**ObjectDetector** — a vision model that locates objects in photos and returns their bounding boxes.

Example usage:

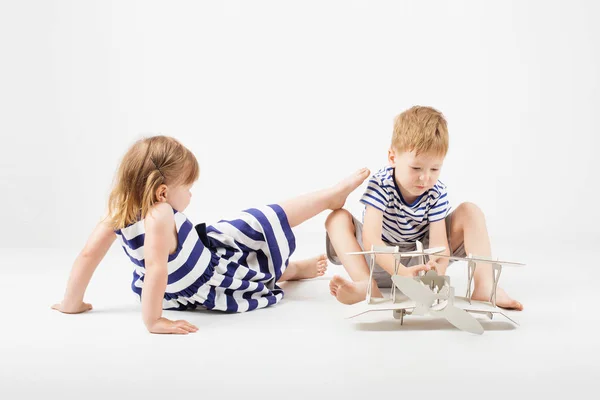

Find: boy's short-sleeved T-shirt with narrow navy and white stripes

[360,167,451,244]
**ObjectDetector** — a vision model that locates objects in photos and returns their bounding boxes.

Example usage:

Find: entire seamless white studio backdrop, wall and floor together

[0,0,600,400]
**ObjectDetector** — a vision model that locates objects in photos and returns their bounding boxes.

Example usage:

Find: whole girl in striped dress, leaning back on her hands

[52,136,369,334]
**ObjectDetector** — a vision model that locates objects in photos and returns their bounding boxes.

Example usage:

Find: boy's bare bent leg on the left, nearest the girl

[325,209,383,304]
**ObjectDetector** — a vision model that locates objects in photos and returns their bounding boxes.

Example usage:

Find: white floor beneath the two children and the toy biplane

[0,237,600,399]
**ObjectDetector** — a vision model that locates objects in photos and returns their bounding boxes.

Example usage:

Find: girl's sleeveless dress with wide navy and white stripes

[115,205,296,312]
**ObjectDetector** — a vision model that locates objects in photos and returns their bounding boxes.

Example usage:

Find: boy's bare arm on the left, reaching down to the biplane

[363,205,430,276]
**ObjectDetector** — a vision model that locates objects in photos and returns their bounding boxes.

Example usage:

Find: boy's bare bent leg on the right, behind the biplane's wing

[448,203,523,310]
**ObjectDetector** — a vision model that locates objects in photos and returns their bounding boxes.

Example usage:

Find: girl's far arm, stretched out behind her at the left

[52,217,116,314]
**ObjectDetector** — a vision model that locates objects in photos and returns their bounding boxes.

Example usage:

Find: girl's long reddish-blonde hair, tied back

[108,136,200,229]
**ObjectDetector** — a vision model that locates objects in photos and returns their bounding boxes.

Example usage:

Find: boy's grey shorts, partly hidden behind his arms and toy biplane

[325,213,467,288]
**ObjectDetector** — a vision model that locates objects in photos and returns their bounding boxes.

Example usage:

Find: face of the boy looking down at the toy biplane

[388,148,445,202]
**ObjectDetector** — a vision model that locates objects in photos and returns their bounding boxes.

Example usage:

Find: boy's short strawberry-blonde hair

[392,106,448,156]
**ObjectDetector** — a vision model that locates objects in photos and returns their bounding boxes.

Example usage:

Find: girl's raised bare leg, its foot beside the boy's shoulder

[280,168,370,228]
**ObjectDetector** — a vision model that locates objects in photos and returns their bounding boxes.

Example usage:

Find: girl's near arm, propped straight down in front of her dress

[142,203,198,334]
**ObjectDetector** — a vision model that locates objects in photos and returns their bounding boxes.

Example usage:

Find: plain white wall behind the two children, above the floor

[0,1,600,248]
